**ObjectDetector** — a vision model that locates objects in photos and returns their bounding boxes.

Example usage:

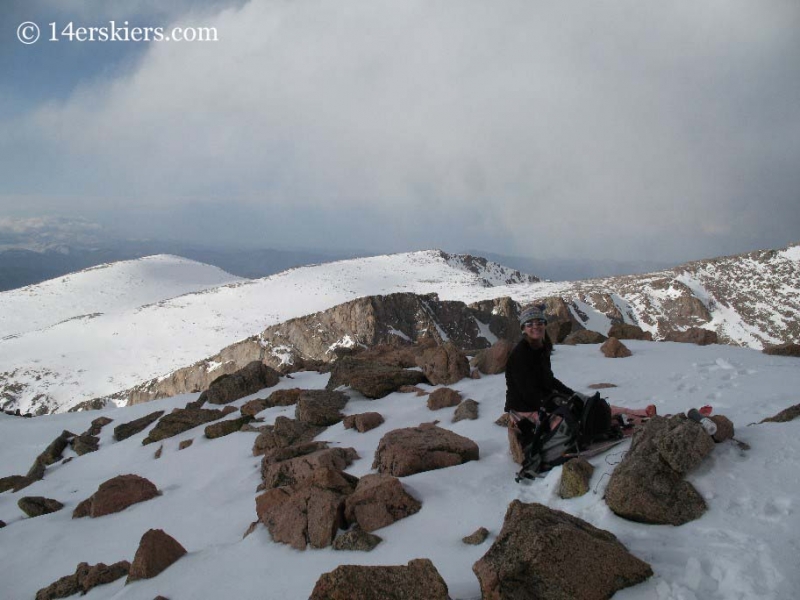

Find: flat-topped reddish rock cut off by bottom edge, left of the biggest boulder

[309,558,450,600]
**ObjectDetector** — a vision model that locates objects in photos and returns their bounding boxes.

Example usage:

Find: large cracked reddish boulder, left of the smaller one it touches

[256,467,354,550]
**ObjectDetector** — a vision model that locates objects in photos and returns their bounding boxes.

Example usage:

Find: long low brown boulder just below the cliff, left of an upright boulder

[325,356,427,399]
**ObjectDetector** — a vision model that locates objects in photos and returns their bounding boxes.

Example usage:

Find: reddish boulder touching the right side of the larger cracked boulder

[345,474,422,531]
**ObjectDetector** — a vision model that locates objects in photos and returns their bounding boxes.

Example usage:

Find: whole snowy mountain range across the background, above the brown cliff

[0,245,800,413]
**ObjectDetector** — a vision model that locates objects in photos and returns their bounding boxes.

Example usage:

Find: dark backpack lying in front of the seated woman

[517,392,622,481]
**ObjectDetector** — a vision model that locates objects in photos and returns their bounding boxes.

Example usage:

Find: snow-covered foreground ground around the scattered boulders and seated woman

[0,342,800,600]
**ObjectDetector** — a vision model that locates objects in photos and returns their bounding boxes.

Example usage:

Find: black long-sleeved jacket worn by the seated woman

[505,337,575,412]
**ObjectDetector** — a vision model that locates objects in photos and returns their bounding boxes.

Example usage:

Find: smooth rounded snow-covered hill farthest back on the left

[0,254,242,338]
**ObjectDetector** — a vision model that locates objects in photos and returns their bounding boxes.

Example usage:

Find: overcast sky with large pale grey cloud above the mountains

[0,0,800,262]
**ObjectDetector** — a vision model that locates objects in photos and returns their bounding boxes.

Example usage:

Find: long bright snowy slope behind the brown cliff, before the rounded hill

[0,250,546,412]
